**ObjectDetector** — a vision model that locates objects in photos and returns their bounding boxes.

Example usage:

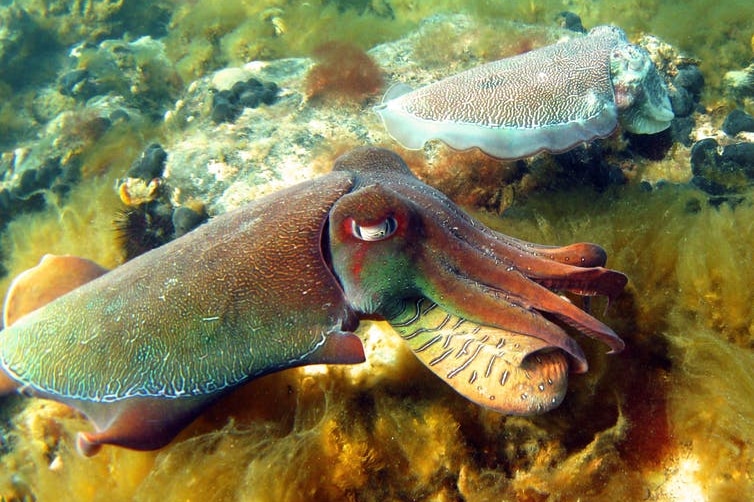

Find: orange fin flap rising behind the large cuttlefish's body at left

[3,254,108,327]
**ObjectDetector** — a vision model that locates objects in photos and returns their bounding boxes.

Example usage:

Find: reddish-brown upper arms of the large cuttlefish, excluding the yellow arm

[328,151,626,358]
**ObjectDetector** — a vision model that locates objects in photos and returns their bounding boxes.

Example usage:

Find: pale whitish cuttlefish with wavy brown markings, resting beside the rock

[375,26,673,159]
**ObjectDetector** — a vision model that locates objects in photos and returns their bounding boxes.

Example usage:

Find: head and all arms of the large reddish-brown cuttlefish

[328,148,627,414]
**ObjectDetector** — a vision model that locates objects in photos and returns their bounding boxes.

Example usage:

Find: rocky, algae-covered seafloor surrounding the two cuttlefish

[0,0,754,501]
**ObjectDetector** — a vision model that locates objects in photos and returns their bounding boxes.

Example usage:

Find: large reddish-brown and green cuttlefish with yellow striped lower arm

[0,148,627,455]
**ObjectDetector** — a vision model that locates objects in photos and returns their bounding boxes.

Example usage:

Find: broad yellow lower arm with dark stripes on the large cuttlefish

[390,298,568,415]
